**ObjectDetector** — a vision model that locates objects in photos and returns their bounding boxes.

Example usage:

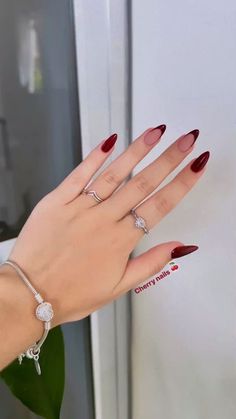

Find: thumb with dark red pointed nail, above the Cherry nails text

[117,241,198,293]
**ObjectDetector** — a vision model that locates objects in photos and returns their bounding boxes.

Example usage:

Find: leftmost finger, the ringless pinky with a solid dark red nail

[53,134,117,204]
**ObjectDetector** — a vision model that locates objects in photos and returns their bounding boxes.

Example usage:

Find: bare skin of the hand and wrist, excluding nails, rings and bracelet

[0,128,208,369]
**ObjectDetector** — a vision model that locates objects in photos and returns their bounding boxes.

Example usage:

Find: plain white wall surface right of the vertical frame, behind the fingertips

[132,0,236,419]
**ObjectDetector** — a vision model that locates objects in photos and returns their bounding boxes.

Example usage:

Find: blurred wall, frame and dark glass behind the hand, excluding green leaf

[0,0,236,419]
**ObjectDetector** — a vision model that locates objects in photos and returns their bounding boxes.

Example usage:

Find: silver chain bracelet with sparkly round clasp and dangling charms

[0,259,54,375]
